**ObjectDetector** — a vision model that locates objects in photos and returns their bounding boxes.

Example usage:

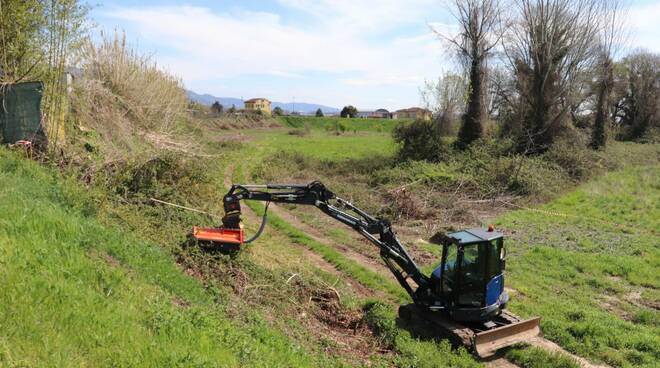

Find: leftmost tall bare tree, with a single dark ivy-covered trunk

[435,0,503,148]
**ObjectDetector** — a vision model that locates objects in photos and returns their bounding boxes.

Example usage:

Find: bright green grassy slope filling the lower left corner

[0,149,336,367]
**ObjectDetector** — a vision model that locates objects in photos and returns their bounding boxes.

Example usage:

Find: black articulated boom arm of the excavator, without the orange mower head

[222,181,431,303]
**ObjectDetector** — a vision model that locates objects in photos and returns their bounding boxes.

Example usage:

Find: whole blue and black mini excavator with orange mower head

[193,181,540,357]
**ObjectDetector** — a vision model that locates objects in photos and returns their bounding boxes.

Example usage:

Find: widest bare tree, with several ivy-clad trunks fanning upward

[505,0,601,153]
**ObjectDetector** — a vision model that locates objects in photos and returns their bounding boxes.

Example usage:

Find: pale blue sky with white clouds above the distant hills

[91,0,660,110]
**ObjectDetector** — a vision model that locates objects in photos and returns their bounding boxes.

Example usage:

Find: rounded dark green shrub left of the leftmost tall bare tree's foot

[392,120,449,162]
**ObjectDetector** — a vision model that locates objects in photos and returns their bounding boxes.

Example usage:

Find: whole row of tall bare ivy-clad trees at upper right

[418,0,660,154]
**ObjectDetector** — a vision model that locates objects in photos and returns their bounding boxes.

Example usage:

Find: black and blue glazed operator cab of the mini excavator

[431,228,509,321]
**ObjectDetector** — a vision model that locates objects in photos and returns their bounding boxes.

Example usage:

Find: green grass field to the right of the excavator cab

[498,165,660,367]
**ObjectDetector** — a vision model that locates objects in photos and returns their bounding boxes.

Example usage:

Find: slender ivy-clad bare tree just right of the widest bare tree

[590,0,625,149]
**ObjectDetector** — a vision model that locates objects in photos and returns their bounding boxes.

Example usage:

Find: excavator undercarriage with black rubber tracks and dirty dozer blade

[399,304,541,358]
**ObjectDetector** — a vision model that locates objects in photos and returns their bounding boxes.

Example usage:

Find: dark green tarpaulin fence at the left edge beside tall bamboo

[0,82,44,143]
